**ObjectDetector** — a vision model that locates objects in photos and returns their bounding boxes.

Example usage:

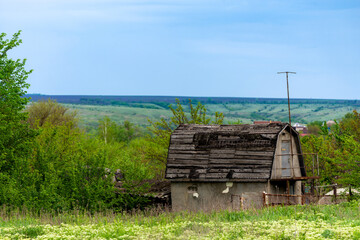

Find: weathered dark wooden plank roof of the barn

[165,123,301,182]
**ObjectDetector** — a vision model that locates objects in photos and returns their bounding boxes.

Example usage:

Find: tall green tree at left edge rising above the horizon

[0,31,36,204]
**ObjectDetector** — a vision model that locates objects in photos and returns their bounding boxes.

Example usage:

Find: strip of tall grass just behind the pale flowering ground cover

[0,201,360,227]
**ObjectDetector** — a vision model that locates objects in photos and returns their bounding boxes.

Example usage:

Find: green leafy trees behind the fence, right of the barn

[301,111,360,187]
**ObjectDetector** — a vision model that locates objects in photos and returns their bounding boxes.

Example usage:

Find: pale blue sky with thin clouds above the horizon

[0,0,360,99]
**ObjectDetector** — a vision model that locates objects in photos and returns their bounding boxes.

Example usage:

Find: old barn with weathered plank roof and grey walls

[166,123,306,211]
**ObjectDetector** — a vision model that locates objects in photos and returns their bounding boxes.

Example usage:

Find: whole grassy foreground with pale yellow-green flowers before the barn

[0,202,360,239]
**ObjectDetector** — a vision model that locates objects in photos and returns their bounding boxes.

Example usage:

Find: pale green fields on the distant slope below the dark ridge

[64,103,357,128]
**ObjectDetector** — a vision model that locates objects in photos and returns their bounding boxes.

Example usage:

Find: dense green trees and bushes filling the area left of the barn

[0,32,156,213]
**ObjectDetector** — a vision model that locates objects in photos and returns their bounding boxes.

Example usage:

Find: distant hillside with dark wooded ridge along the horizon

[27,94,360,129]
